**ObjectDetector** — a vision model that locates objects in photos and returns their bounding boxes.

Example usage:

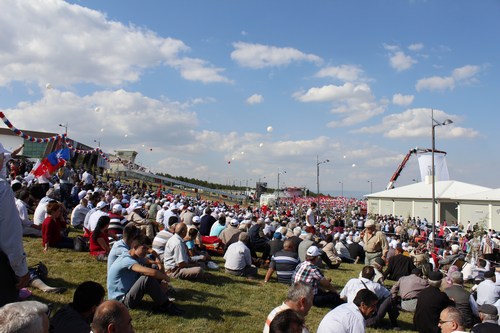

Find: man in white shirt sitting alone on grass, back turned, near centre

[224,232,257,277]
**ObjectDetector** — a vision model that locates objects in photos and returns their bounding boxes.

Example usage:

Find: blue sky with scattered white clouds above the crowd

[0,0,500,194]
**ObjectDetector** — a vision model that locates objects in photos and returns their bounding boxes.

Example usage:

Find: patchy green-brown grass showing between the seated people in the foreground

[24,233,418,333]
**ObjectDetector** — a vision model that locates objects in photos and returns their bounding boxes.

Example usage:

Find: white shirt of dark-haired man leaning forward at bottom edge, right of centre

[316,303,365,333]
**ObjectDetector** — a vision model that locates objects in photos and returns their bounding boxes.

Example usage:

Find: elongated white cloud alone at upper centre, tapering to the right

[231,42,322,68]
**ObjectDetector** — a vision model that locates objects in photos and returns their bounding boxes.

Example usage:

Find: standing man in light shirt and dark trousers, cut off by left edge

[0,146,30,307]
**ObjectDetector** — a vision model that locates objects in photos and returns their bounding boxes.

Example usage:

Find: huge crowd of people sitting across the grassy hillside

[0,146,500,333]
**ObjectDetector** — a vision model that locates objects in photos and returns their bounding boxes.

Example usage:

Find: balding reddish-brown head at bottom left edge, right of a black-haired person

[92,301,134,333]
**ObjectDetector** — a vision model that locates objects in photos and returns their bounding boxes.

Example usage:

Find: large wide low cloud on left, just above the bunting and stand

[5,89,198,149]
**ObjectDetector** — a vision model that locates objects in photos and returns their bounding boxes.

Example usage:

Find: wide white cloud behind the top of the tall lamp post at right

[354,108,479,139]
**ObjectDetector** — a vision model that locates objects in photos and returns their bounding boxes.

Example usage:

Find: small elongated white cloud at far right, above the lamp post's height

[415,65,480,91]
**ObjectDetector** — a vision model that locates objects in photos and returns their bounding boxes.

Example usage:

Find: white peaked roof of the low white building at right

[365,180,494,200]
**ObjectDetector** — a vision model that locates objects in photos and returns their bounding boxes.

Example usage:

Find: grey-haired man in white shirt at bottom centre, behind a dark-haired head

[263,280,313,333]
